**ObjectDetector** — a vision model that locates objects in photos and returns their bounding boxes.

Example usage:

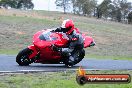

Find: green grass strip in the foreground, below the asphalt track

[0,71,132,88]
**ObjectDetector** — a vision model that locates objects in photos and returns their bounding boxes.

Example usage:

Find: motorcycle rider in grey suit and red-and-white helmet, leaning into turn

[53,19,84,65]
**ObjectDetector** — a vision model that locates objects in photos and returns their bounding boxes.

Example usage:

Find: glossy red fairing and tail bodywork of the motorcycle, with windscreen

[28,30,93,63]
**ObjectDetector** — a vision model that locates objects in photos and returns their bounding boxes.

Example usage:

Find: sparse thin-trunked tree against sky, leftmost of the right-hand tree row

[55,0,72,14]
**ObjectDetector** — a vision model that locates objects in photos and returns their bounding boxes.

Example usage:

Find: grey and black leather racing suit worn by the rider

[54,27,84,64]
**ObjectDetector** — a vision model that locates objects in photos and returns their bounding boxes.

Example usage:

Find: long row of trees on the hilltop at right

[55,0,132,24]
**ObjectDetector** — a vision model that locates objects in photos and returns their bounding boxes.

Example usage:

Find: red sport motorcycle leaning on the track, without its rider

[16,29,95,66]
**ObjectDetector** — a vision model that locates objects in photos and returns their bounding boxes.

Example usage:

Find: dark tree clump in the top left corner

[0,0,34,10]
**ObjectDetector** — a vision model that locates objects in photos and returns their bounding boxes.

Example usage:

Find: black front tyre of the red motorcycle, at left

[16,48,32,66]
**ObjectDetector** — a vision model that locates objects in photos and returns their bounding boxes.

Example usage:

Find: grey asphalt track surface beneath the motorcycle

[0,55,132,72]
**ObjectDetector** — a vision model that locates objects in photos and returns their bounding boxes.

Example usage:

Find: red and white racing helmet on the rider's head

[61,19,74,35]
